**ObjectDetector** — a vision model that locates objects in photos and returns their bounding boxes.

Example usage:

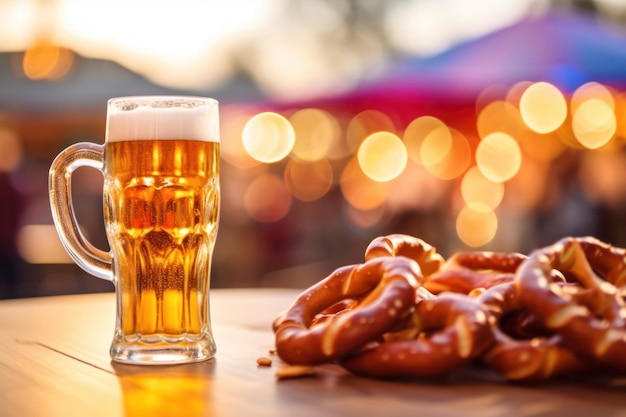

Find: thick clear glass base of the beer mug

[110,337,216,365]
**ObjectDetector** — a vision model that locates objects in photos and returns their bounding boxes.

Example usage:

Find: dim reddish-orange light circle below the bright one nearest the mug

[243,174,292,223]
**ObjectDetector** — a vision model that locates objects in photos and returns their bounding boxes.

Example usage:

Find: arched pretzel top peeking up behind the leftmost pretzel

[365,234,444,277]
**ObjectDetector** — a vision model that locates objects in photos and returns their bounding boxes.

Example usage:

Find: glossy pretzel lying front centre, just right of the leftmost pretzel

[340,293,493,378]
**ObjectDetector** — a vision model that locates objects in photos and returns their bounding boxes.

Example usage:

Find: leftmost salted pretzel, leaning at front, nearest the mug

[273,257,423,365]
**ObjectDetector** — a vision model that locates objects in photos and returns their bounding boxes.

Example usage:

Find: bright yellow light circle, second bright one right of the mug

[357,132,408,182]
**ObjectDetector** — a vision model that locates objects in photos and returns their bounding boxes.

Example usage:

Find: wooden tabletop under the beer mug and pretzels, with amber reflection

[0,289,626,417]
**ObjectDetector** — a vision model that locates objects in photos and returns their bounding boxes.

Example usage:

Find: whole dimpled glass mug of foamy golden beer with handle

[49,96,220,364]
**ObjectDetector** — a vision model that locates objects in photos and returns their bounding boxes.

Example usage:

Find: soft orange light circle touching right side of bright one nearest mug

[289,108,340,161]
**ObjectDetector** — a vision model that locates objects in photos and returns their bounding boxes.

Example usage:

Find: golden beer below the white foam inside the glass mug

[104,140,220,342]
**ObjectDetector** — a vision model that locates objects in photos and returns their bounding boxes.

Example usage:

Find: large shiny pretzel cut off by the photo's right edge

[516,237,626,370]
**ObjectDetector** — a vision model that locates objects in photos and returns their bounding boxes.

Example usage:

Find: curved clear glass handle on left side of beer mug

[48,142,113,281]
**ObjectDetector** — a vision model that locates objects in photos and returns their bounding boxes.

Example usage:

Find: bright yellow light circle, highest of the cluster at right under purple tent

[519,82,567,133]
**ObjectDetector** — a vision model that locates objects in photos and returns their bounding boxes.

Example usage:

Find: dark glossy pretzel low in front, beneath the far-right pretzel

[478,282,587,381]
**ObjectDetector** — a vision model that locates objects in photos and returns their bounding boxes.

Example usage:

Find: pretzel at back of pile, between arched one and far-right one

[424,251,564,294]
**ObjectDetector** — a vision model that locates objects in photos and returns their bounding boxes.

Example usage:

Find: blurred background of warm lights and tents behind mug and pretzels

[0,0,626,298]
